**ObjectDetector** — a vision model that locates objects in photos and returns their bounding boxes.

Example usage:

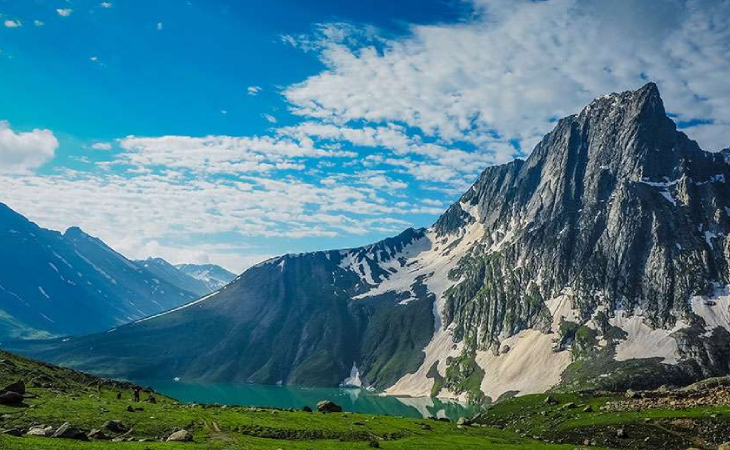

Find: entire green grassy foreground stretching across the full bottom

[0,351,730,450]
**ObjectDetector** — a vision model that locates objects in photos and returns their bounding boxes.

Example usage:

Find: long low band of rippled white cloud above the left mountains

[0,158,438,267]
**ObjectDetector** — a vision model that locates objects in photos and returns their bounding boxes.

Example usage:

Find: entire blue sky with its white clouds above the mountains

[0,0,730,271]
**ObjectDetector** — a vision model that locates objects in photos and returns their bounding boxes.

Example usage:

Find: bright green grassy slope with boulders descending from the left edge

[0,352,604,450]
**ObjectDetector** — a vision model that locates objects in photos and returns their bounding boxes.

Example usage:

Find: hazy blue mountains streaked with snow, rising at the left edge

[0,203,233,339]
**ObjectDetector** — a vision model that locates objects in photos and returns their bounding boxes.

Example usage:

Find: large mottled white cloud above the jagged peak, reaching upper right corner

[285,0,730,153]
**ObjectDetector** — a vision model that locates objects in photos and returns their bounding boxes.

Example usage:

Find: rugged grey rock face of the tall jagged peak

[438,84,730,348]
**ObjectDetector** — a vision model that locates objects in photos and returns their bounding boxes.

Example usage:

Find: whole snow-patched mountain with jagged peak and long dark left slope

[9,83,730,401]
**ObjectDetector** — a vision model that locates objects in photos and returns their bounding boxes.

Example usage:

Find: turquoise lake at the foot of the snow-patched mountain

[139,380,477,420]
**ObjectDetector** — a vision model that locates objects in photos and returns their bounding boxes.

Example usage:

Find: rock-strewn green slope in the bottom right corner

[477,384,730,450]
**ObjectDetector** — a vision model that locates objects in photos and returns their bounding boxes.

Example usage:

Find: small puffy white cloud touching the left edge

[0,121,58,172]
